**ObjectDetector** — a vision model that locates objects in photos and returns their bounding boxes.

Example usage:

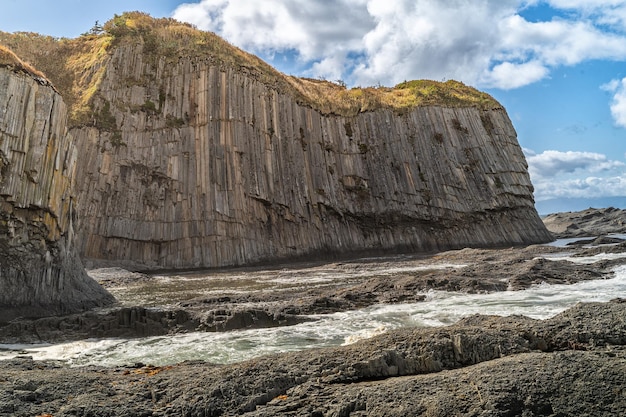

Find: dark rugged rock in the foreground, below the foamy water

[0,300,626,417]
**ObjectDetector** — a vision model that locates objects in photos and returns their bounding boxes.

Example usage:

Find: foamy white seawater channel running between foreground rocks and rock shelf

[0,254,626,366]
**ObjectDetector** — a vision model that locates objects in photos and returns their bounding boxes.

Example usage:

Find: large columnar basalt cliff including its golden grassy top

[4,13,551,268]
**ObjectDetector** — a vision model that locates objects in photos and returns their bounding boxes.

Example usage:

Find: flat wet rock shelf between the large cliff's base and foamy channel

[0,244,626,343]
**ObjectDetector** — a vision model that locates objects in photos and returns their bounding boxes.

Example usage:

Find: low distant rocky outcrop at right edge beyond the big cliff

[543,207,626,239]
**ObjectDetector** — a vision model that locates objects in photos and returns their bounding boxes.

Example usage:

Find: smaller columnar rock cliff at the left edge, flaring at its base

[0,67,113,321]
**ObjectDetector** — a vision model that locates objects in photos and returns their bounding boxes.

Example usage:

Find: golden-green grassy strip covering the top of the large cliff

[0,12,502,124]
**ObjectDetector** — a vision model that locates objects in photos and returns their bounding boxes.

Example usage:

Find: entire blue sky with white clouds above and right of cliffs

[0,0,626,214]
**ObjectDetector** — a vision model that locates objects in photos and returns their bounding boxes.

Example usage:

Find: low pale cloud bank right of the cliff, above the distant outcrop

[524,149,626,201]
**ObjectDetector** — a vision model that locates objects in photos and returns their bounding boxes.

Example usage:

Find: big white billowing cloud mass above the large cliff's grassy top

[173,0,626,89]
